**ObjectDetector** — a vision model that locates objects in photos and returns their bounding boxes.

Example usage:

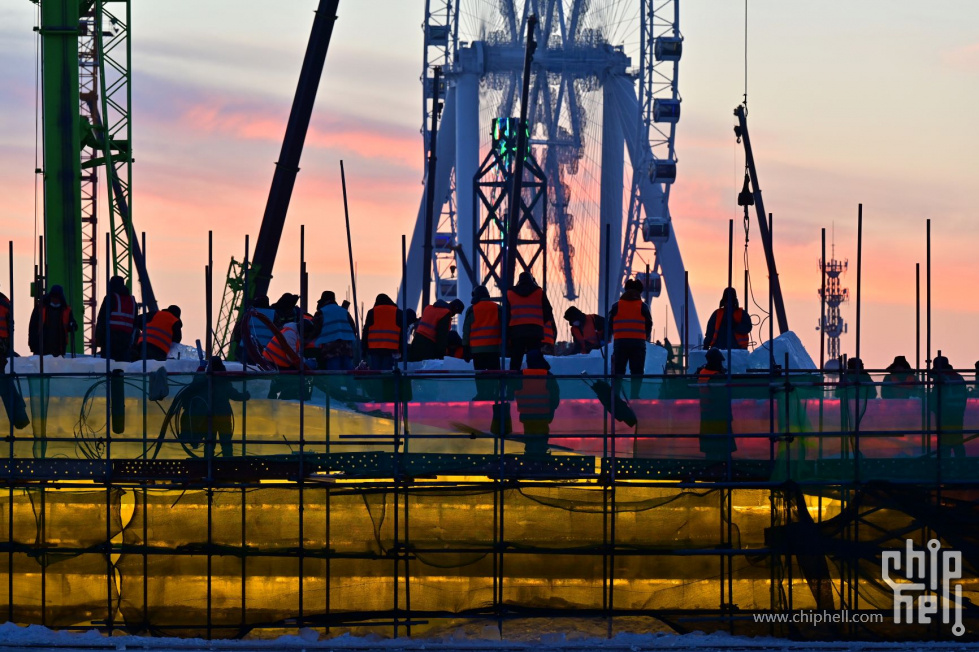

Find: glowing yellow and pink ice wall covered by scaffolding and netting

[0,361,979,640]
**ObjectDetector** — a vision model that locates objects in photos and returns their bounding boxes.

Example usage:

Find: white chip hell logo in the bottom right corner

[881,539,965,636]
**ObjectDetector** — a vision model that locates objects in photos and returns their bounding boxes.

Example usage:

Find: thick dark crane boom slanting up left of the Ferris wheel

[246,0,340,299]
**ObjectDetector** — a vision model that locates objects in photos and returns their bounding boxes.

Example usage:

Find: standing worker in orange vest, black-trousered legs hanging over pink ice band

[607,279,653,398]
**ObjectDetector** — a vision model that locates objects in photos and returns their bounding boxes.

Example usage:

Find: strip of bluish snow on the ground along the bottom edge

[0,623,976,652]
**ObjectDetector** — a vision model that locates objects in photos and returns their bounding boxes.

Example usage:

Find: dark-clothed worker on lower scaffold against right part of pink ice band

[697,347,737,461]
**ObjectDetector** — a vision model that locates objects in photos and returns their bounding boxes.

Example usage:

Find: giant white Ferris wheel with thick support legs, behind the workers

[406,0,701,344]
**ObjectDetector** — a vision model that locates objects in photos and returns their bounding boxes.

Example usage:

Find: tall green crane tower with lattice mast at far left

[37,0,156,352]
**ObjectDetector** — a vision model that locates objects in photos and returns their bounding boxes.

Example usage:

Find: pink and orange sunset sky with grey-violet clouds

[0,0,979,368]
